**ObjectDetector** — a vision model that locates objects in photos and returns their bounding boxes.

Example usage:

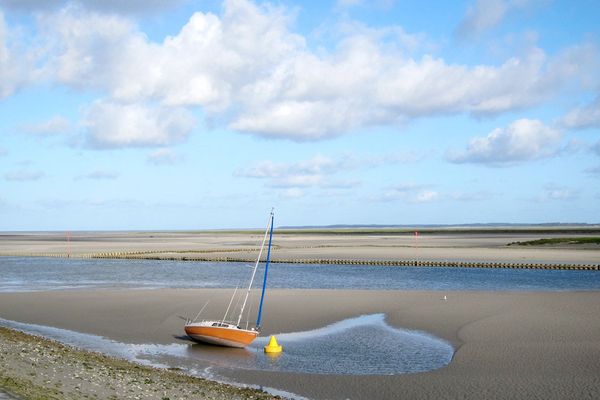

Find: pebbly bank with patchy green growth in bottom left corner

[0,327,279,400]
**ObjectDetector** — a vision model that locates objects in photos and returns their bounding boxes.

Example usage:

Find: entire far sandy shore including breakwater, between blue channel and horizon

[0,228,600,269]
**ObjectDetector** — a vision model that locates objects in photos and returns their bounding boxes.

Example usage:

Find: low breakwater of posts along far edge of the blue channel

[0,248,600,271]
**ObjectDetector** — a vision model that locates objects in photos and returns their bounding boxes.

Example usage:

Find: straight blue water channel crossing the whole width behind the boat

[0,257,600,292]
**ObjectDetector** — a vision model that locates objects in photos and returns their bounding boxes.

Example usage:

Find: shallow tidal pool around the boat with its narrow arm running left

[0,314,454,378]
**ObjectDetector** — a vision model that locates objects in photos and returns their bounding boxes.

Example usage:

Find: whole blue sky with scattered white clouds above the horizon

[0,0,600,231]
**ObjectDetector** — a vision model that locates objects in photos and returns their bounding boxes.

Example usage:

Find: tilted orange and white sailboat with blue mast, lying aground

[185,210,274,348]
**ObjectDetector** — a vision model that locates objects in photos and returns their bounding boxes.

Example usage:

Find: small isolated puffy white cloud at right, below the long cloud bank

[447,119,561,166]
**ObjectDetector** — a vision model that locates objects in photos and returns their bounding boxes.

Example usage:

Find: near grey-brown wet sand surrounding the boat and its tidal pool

[0,289,600,399]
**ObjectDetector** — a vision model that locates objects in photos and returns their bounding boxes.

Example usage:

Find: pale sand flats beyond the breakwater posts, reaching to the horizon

[0,230,600,264]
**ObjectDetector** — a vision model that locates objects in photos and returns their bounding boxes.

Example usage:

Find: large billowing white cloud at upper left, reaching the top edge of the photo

[42,0,303,110]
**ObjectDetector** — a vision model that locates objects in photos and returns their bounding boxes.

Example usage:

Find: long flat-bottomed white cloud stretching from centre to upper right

[230,35,579,141]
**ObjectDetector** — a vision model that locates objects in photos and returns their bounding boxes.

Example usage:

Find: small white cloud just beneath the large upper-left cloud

[84,101,195,148]
